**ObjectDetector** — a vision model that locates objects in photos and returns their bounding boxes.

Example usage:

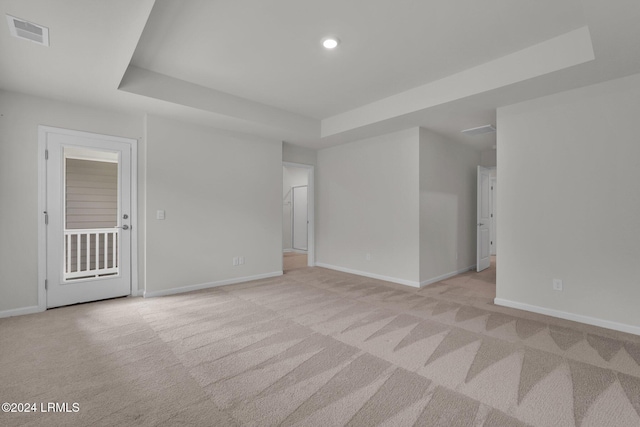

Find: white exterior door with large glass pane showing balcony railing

[44,128,132,307]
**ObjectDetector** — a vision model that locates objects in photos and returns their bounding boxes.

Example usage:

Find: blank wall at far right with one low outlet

[497,75,640,333]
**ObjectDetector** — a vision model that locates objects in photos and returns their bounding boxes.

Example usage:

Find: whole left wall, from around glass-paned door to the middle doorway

[0,91,282,315]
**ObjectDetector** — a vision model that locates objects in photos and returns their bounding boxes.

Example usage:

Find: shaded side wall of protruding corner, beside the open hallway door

[420,128,480,284]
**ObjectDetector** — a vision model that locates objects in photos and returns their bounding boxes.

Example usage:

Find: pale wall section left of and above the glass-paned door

[0,91,143,312]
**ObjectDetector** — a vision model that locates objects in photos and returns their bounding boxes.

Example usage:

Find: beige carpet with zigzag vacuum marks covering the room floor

[0,262,640,427]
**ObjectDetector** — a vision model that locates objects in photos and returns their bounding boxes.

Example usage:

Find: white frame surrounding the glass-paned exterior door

[38,125,140,311]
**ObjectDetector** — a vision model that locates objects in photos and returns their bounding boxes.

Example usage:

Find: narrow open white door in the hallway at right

[476,166,491,271]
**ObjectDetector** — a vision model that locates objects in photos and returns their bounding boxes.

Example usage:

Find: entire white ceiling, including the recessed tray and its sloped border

[0,0,640,149]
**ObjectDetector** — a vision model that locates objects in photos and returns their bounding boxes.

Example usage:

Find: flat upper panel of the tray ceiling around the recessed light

[131,0,585,119]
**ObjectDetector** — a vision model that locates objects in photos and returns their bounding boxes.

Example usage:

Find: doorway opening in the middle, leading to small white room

[282,162,315,272]
